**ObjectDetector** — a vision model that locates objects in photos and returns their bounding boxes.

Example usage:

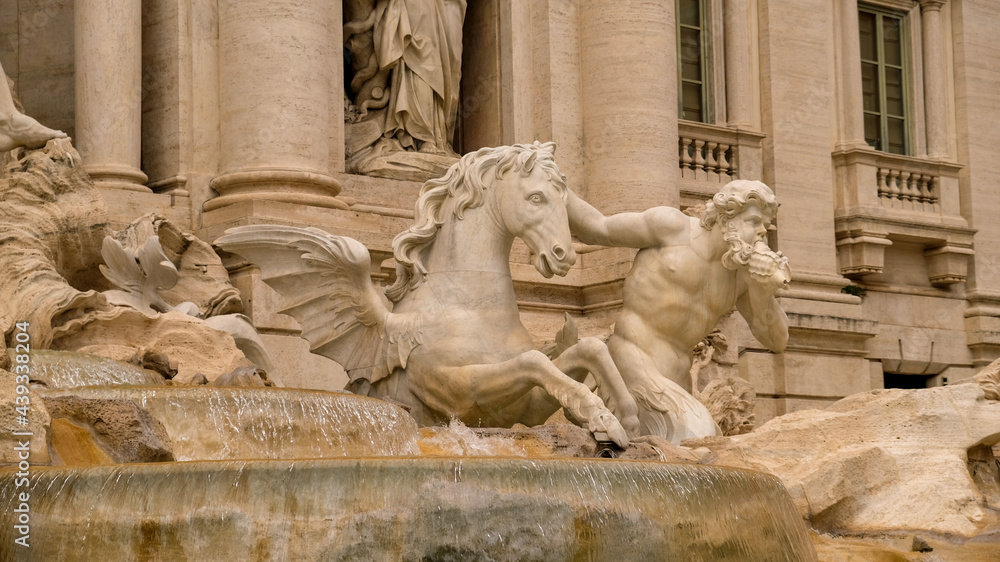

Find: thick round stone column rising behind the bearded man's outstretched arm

[579,0,680,213]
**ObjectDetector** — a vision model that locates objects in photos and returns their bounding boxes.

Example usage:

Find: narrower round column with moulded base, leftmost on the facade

[74,0,149,192]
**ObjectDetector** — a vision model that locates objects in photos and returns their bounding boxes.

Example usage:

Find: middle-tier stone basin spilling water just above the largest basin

[42,386,419,461]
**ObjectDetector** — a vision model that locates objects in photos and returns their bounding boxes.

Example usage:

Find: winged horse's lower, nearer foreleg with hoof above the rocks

[418,350,628,447]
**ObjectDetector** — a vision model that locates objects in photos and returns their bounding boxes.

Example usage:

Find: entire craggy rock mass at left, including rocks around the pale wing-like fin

[0,139,271,382]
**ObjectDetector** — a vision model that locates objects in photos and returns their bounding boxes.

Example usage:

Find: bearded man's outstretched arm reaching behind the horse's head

[566,191,690,248]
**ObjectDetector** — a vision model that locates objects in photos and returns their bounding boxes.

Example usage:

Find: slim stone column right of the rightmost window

[920,0,948,158]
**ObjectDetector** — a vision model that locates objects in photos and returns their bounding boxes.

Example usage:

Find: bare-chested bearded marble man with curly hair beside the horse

[568,180,791,443]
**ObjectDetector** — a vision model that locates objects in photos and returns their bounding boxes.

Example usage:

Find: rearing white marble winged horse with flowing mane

[216,142,638,446]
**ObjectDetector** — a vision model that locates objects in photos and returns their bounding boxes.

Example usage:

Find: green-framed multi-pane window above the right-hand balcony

[858,3,917,156]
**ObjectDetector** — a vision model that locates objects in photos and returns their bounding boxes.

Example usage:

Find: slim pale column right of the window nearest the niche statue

[725,0,753,129]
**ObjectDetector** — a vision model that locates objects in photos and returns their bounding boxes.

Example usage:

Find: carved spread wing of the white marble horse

[215,225,420,383]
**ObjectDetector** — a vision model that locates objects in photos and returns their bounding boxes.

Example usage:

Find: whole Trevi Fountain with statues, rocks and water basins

[0,0,1000,561]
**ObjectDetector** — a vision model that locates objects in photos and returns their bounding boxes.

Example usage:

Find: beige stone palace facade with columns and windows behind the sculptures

[7,0,1000,420]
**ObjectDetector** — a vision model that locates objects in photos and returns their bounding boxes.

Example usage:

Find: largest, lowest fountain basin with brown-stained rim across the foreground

[0,458,816,562]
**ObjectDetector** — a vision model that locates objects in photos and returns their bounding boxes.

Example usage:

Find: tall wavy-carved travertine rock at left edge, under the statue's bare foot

[0,139,111,348]
